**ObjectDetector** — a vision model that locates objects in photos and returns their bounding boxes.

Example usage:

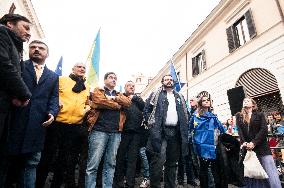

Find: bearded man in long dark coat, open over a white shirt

[145,75,188,188]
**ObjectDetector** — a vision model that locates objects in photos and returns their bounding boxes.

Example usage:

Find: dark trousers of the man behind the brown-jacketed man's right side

[114,132,140,187]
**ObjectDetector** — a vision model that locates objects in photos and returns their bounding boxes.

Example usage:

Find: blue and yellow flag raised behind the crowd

[86,29,100,87]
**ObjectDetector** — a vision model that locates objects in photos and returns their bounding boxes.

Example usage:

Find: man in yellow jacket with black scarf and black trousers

[37,63,90,187]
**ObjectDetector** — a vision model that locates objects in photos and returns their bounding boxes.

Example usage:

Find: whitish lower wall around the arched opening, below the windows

[189,36,284,120]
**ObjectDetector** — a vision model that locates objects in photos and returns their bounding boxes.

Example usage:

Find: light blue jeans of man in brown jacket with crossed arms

[86,130,121,188]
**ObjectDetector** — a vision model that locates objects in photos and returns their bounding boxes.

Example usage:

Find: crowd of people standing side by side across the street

[0,14,282,188]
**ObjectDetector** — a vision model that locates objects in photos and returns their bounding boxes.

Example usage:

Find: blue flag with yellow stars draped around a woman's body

[189,112,225,159]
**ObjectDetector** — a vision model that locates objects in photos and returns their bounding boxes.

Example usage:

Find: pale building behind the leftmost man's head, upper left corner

[0,0,44,59]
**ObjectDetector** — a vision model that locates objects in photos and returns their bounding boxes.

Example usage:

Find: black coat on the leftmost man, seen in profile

[0,24,31,112]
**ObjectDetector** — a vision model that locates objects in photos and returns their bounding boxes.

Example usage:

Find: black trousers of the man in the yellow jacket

[51,122,88,188]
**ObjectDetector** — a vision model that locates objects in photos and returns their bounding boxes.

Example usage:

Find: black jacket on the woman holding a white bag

[236,111,271,157]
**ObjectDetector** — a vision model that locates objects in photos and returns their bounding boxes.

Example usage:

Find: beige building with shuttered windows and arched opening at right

[141,0,284,120]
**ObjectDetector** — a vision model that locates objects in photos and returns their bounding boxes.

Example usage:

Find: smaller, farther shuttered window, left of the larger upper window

[192,50,207,77]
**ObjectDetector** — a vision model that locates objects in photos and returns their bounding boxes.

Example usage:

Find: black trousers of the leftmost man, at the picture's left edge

[0,113,10,188]
